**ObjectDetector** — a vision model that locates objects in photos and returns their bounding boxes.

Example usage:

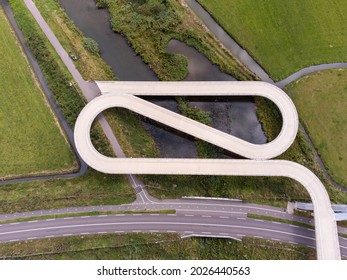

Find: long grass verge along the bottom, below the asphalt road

[0,233,316,260]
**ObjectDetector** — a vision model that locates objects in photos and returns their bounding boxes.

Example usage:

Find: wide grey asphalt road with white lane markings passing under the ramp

[0,211,347,257]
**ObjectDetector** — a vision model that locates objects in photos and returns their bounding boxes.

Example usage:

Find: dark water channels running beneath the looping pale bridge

[59,0,266,157]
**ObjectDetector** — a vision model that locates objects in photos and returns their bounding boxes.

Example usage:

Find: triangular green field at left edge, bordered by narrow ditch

[0,9,77,179]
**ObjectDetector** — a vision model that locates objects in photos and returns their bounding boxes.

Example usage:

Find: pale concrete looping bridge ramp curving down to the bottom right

[75,82,340,259]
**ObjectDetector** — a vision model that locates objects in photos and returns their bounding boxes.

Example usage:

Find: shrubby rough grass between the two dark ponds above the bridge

[102,0,254,80]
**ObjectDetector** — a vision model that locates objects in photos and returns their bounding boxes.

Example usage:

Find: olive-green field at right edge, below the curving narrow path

[286,69,347,186]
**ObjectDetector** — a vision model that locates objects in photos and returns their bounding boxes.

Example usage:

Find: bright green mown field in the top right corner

[198,0,347,80]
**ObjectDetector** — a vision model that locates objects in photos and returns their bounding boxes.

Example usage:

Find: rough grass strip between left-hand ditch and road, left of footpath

[0,170,135,213]
